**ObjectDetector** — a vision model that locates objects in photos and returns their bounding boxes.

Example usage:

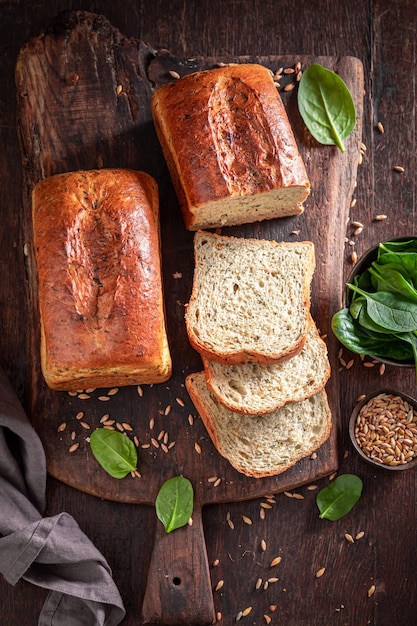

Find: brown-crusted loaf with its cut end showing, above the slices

[152,64,310,230]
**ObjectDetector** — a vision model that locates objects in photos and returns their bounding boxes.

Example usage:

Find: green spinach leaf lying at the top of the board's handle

[155,476,194,533]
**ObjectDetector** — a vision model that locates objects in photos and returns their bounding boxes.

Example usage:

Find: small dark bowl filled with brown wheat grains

[349,389,417,471]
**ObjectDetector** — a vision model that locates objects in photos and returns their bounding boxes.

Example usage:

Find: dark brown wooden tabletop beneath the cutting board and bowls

[0,0,417,626]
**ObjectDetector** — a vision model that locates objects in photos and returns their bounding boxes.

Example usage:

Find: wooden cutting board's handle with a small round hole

[142,506,215,626]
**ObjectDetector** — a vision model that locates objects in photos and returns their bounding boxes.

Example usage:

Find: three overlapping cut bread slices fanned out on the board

[185,231,331,478]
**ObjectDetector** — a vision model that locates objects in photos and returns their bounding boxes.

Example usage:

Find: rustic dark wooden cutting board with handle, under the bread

[16,11,363,624]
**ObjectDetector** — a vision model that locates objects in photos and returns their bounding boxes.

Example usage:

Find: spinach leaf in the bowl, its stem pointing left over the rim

[348,283,417,332]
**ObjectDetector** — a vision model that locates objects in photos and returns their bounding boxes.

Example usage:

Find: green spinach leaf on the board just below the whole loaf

[90,428,138,478]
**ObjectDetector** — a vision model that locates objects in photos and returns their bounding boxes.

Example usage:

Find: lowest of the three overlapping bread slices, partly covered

[185,372,331,478]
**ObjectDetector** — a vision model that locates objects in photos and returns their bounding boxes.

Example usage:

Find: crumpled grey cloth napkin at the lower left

[0,370,126,626]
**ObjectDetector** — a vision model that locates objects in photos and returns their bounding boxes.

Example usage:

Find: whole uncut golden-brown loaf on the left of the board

[32,169,172,390]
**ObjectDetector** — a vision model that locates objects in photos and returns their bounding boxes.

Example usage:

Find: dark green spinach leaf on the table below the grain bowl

[316,474,363,522]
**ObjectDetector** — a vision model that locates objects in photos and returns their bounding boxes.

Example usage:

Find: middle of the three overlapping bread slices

[203,320,330,415]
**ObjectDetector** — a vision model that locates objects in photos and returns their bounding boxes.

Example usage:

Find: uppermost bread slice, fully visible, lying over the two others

[185,231,315,365]
